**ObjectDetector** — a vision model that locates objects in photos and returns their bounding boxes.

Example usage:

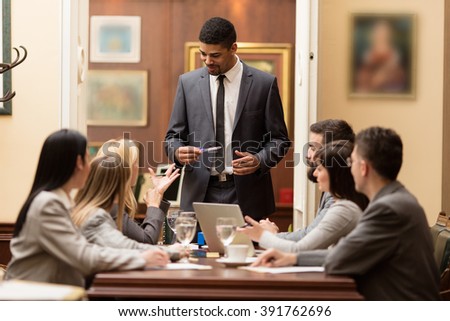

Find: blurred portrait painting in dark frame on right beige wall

[349,13,416,98]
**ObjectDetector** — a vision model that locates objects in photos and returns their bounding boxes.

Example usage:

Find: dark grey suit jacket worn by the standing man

[165,64,290,218]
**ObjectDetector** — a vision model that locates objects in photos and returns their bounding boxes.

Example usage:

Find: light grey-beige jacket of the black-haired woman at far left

[5,189,145,286]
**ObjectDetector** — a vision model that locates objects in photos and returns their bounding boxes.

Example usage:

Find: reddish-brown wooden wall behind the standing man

[88,0,295,205]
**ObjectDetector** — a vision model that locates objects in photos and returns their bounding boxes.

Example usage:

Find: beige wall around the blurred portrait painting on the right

[318,0,444,224]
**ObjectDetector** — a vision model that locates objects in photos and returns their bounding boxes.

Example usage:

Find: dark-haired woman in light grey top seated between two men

[238,141,369,252]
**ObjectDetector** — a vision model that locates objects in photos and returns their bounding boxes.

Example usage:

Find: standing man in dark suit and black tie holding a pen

[165,17,290,219]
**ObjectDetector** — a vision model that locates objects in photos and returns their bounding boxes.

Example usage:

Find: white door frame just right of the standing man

[294,0,319,229]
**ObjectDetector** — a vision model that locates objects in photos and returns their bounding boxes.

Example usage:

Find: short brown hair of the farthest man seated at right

[309,119,355,145]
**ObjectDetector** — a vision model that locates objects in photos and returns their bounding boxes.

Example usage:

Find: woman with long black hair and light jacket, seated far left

[5,129,169,286]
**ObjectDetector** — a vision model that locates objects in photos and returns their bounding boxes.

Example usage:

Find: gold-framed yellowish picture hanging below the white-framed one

[87,70,147,126]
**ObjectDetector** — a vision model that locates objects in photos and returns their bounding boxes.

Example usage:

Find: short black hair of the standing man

[198,17,236,49]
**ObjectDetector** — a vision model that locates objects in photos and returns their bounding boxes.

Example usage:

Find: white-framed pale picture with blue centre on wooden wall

[90,16,141,63]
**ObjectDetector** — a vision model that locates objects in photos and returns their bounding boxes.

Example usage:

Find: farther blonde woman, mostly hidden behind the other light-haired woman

[97,139,170,244]
